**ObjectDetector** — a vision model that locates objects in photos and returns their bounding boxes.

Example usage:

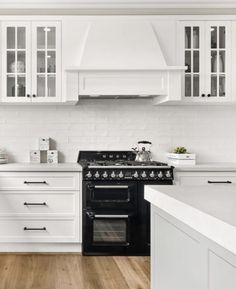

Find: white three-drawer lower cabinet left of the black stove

[0,172,81,245]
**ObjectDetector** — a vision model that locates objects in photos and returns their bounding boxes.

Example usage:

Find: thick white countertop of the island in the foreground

[145,185,236,254]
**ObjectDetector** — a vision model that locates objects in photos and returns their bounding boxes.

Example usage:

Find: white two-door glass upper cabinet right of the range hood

[181,21,232,102]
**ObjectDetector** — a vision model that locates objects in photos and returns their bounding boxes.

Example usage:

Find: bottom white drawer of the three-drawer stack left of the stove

[0,218,78,243]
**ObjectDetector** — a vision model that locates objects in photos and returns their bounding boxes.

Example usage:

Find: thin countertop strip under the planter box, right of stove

[174,163,236,172]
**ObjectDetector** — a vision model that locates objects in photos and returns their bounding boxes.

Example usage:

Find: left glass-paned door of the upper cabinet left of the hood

[2,22,31,102]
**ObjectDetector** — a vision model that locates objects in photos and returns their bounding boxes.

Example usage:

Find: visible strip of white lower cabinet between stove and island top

[174,171,236,186]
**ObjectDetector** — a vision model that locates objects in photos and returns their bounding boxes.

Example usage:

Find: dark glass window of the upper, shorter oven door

[92,186,130,202]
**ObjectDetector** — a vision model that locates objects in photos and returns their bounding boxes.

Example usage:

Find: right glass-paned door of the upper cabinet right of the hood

[206,21,231,100]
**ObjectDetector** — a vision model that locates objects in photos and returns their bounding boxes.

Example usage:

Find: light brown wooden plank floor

[0,254,150,289]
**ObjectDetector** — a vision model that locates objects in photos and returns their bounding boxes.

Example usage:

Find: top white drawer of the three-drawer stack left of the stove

[0,172,79,191]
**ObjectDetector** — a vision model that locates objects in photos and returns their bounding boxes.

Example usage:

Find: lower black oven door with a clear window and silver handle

[83,211,136,255]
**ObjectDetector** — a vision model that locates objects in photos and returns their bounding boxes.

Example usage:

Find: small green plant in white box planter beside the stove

[167,146,196,165]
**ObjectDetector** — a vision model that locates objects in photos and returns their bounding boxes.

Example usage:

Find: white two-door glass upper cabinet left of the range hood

[2,22,61,103]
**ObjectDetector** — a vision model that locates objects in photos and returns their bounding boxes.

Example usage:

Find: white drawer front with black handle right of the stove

[178,175,236,186]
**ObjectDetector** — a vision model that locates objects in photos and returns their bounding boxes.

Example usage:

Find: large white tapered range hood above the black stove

[65,20,185,100]
